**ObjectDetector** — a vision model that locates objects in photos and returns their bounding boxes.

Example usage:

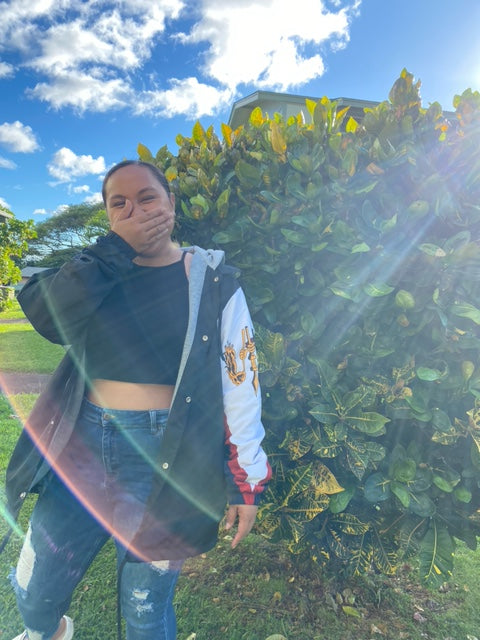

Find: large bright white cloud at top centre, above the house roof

[180,0,358,90]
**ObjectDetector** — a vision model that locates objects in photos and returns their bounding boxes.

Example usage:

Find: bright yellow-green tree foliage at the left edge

[0,207,35,310]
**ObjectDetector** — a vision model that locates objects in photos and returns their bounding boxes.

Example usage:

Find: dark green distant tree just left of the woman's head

[25,203,108,267]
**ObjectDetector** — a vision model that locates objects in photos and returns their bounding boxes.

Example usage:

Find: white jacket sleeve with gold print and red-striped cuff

[221,288,271,504]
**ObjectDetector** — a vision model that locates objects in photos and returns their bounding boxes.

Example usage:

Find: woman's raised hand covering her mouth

[110,199,175,255]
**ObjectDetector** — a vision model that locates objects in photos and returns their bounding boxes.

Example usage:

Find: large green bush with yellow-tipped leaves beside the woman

[139,70,480,583]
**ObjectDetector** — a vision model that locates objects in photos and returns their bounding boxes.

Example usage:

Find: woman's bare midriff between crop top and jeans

[87,379,174,411]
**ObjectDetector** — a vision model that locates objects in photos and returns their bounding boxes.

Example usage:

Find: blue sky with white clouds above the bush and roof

[0,0,480,222]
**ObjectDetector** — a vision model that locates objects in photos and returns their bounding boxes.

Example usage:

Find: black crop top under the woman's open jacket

[86,252,188,385]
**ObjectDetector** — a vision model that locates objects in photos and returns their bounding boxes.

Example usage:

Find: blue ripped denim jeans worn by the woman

[12,400,182,640]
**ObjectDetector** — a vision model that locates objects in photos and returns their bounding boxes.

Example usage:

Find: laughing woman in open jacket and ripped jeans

[7,161,270,640]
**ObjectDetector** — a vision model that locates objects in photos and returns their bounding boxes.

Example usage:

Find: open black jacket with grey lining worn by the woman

[1,232,270,560]
